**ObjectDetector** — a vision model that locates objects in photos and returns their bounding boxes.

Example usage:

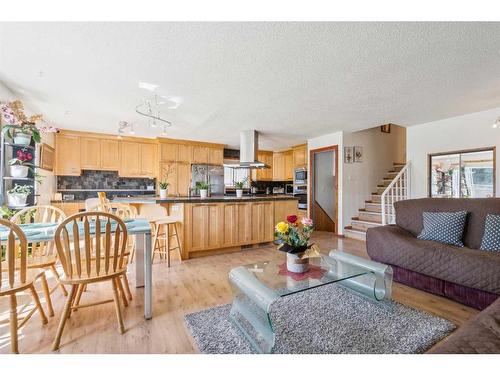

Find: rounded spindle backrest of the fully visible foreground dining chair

[54,212,129,279]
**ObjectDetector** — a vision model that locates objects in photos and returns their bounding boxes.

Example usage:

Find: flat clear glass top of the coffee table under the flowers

[238,255,370,297]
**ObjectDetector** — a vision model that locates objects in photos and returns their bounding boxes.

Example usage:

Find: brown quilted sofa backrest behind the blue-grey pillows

[394,198,500,249]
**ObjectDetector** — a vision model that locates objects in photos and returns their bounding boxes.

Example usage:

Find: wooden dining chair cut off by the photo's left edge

[0,219,50,353]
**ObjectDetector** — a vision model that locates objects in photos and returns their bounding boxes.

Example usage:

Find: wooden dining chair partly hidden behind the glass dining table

[10,205,68,316]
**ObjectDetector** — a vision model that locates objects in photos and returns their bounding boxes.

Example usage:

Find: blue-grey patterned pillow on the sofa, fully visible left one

[418,211,467,247]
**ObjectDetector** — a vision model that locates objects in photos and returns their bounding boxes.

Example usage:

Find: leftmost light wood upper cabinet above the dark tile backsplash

[55,134,82,176]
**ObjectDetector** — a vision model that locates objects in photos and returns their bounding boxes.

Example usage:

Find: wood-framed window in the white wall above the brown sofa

[429,148,495,198]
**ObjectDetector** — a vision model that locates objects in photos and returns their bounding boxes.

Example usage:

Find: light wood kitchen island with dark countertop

[113,195,299,259]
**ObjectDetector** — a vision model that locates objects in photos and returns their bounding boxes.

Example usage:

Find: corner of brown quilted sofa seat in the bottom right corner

[429,298,500,354]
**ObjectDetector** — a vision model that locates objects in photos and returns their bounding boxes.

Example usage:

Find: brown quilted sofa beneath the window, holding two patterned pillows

[366,198,500,310]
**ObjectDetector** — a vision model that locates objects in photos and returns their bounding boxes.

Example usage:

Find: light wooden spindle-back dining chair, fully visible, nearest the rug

[52,212,129,350]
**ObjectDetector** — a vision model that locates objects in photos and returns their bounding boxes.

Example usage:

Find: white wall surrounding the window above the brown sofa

[407,107,500,198]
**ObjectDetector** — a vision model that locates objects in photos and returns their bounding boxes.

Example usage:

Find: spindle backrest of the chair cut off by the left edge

[0,219,28,291]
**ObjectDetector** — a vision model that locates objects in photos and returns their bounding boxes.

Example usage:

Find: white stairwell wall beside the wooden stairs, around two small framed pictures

[342,125,406,229]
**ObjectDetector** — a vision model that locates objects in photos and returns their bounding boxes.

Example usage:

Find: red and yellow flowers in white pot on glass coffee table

[275,215,320,273]
